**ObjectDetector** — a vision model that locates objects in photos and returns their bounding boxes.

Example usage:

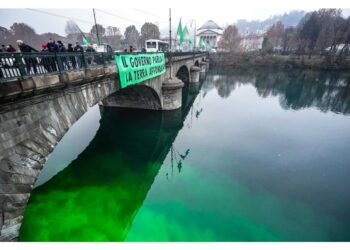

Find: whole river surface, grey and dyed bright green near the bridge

[20,67,350,241]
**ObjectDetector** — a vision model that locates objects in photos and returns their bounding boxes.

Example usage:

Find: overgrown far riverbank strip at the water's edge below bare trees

[210,52,350,70]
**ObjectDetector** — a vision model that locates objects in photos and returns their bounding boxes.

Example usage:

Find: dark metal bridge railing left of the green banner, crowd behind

[0,52,114,82]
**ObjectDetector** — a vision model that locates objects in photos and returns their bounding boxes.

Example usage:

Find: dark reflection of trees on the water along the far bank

[209,69,350,114]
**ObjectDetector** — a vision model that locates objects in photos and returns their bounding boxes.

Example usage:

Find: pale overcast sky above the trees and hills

[0,0,347,35]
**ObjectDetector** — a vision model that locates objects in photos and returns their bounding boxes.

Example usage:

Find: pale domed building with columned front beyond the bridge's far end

[196,20,223,49]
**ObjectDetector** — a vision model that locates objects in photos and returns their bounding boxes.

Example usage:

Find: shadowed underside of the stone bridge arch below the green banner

[102,84,162,110]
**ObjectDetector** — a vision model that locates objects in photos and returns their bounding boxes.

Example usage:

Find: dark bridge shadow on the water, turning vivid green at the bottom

[19,75,205,241]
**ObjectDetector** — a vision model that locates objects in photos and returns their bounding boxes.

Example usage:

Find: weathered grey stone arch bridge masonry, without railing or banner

[0,51,208,241]
